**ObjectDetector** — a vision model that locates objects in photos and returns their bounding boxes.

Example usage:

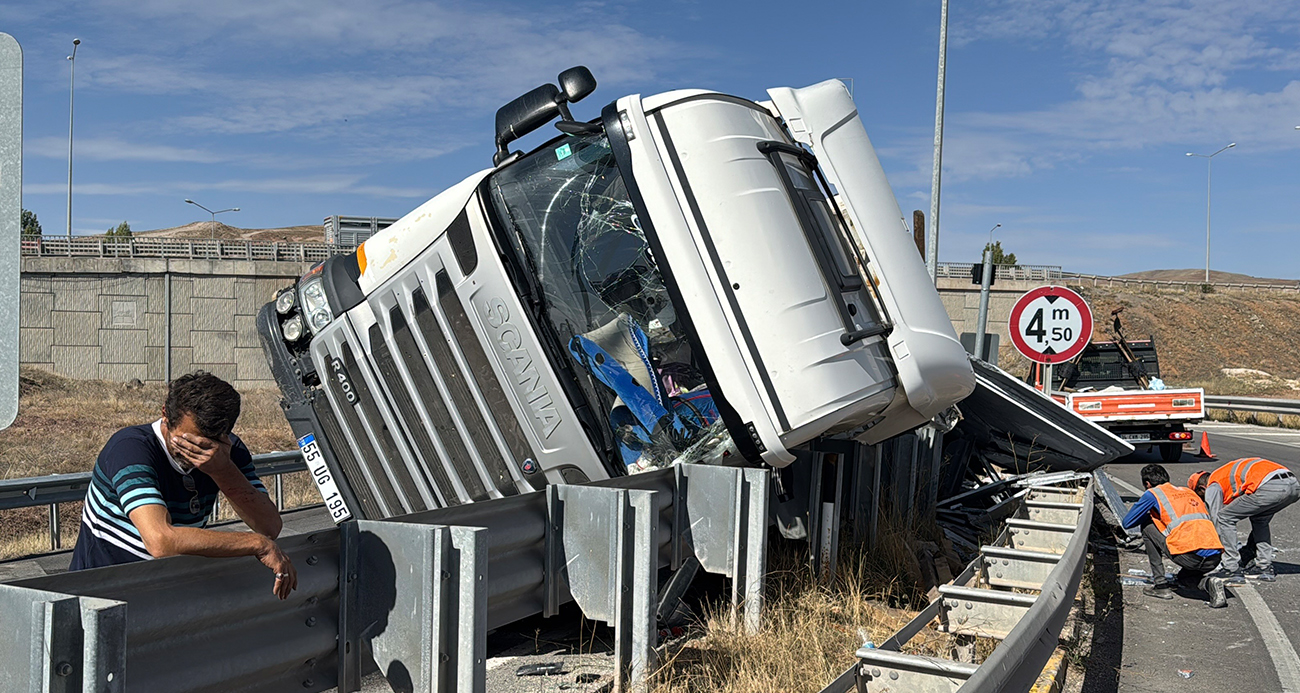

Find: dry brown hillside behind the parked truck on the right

[1060,286,1300,398]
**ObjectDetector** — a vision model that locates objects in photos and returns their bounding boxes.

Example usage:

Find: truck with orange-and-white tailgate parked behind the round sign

[1040,308,1205,463]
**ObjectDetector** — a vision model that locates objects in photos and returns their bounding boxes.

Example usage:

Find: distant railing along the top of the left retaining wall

[22,235,356,263]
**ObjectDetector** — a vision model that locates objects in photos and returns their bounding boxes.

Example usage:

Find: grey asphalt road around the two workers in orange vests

[1084,423,1300,693]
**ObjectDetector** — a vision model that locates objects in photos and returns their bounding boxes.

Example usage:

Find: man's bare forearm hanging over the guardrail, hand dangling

[129,504,298,599]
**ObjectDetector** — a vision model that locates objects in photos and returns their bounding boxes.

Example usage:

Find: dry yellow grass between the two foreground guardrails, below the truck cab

[651,512,992,693]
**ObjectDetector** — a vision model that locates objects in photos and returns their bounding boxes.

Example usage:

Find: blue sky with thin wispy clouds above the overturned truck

[0,0,1300,278]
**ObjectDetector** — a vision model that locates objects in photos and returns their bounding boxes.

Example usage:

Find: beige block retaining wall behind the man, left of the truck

[20,257,308,387]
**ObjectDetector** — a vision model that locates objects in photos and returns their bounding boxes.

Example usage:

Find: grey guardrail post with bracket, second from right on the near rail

[546,485,659,692]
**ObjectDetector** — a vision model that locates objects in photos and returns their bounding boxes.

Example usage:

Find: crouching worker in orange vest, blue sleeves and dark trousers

[1123,464,1227,608]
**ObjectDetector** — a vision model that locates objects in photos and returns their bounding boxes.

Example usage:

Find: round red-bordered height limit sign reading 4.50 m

[1009,286,1092,363]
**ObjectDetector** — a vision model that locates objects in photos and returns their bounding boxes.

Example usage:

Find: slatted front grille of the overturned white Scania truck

[313,245,546,509]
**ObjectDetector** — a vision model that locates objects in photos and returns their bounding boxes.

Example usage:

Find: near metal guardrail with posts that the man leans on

[0,464,768,693]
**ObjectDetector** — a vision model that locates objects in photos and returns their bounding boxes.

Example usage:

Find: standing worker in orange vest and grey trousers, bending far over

[1187,458,1300,584]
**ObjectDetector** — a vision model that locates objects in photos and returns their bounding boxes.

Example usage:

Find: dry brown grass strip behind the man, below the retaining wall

[0,368,305,559]
